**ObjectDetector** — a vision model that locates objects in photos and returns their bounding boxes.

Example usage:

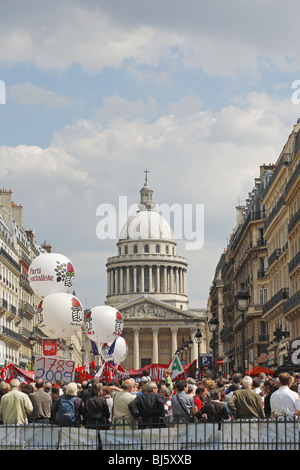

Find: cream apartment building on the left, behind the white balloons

[0,189,81,370]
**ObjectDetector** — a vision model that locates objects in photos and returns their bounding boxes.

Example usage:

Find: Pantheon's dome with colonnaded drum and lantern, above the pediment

[106,177,188,310]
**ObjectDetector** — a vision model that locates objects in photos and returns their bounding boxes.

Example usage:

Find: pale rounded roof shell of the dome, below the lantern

[119,210,174,241]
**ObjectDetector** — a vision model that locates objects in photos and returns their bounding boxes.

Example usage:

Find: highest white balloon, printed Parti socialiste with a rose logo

[28,253,75,297]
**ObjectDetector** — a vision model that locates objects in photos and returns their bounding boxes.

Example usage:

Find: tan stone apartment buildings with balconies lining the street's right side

[208,120,300,374]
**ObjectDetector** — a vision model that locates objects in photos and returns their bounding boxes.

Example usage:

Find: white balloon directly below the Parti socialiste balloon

[37,292,83,338]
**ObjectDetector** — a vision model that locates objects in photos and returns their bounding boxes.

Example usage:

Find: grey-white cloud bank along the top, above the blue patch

[0,0,300,81]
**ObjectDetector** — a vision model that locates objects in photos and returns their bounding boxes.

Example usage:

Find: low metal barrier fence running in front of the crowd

[0,417,300,452]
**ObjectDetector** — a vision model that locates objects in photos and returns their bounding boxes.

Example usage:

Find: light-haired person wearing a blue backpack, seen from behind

[52,382,83,427]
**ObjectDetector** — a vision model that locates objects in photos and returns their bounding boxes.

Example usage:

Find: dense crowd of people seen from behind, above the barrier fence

[0,370,300,429]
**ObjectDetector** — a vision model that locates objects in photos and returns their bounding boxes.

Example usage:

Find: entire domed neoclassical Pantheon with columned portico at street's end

[106,177,206,370]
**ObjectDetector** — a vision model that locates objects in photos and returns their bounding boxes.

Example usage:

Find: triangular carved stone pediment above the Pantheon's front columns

[117,295,201,321]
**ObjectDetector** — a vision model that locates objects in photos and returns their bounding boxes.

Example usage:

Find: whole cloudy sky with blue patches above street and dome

[0,0,300,307]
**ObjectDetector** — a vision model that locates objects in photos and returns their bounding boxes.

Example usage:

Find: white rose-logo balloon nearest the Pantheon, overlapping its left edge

[84,305,123,343]
